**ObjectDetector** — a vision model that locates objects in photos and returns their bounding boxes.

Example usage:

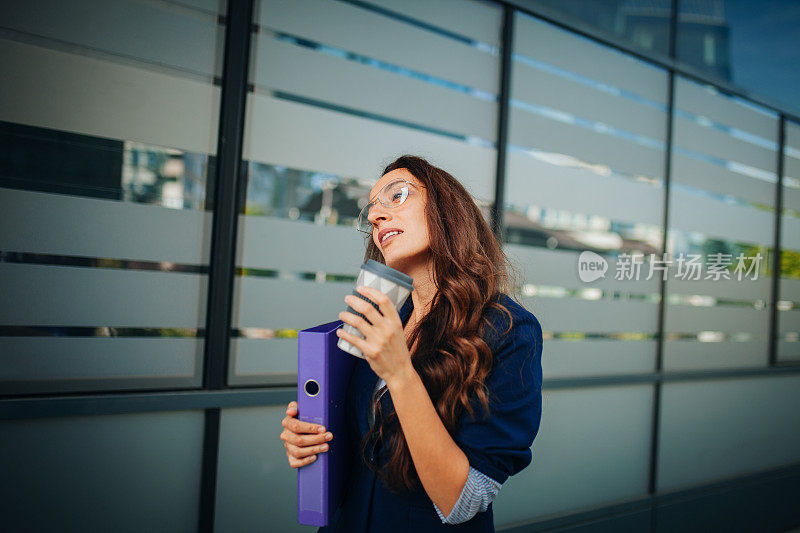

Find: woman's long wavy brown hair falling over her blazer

[361,155,519,492]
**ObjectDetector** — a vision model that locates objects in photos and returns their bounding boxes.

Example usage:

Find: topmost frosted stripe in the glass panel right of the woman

[514,12,667,104]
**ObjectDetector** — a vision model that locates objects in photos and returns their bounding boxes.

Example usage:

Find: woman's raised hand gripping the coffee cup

[336,286,413,386]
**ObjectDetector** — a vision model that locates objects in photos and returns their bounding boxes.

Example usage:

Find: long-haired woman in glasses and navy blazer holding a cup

[281,155,542,533]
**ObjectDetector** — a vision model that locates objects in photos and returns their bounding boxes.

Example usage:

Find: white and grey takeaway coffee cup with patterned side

[337,259,414,359]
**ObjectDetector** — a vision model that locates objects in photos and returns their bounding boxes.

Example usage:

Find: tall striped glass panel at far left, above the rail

[0,0,226,393]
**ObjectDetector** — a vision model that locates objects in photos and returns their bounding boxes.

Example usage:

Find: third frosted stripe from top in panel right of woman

[509,109,664,178]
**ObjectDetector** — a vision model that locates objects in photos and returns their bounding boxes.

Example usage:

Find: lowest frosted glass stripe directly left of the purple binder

[229,338,296,376]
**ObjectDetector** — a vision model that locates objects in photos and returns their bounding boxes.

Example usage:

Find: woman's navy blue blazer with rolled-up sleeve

[318,294,542,533]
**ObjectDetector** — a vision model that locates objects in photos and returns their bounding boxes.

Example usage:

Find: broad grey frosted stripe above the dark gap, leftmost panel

[0,39,220,154]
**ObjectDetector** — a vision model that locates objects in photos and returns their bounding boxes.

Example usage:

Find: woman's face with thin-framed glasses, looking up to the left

[368,168,430,272]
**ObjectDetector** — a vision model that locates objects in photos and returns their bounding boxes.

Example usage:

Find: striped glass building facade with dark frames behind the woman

[0,0,800,532]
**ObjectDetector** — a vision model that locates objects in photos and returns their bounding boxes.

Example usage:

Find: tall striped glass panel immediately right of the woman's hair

[504,13,668,378]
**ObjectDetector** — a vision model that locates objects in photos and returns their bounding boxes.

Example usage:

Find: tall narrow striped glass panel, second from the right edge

[664,77,778,370]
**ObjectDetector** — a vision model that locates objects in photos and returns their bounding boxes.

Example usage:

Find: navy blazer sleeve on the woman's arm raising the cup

[453,308,542,484]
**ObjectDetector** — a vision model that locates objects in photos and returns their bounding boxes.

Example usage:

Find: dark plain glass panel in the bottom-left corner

[0,411,203,533]
